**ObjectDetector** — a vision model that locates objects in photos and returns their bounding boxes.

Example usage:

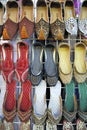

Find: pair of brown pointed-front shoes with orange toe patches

[3,0,34,40]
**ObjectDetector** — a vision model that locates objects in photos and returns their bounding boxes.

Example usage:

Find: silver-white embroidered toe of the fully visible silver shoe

[65,17,77,35]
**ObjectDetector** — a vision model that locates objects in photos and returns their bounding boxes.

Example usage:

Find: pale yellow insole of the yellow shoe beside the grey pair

[59,45,71,74]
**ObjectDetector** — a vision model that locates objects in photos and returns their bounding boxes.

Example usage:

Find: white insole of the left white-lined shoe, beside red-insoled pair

[33,80,47,117]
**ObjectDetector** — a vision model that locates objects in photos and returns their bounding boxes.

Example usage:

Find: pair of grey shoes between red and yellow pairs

[31,43,58,86]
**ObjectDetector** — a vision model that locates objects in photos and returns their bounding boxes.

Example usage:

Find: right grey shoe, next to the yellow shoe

[44,44,58,86]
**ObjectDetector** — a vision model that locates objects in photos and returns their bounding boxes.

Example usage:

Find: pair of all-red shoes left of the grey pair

[1,42,29,82]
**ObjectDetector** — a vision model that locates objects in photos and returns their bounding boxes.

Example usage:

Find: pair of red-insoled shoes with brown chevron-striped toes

[3,80,32,121]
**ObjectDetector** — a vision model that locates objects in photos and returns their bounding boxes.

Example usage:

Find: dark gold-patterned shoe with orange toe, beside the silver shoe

[50,1,65,40]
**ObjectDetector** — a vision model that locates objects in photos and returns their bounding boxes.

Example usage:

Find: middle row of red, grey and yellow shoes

[0,41,87,86]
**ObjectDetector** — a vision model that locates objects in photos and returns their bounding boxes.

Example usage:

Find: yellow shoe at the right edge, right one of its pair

[74,43,87,83]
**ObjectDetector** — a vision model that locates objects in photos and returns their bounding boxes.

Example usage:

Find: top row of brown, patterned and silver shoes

[0,0,87,40]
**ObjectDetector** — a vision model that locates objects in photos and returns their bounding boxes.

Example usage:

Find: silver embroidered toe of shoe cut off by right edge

[79,19,87,37]
